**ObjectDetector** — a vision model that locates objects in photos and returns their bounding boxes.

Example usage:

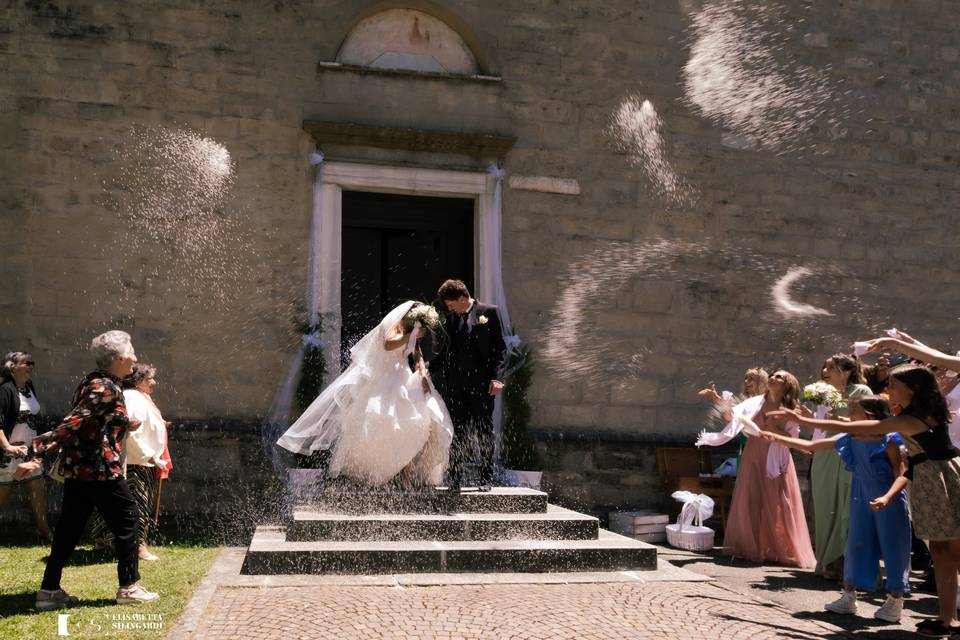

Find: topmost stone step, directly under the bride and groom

[297,485,547,514]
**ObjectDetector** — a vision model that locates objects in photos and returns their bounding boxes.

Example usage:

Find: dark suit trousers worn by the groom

[443,383,494,484]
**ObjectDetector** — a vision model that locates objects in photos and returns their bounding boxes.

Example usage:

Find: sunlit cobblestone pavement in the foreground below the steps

[184,582,846,640]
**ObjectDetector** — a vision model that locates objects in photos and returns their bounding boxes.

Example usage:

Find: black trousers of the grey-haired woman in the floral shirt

[40,478,140,590]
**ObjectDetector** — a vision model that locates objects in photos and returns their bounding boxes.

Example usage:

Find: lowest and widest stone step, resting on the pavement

[242,526,657,575]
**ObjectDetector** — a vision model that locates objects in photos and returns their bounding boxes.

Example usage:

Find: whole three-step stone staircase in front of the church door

[242,470,657,575]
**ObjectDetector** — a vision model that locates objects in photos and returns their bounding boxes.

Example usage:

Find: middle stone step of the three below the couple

[286,504,600,542]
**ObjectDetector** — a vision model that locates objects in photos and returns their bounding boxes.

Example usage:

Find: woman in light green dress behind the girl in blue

[810,353,873,580]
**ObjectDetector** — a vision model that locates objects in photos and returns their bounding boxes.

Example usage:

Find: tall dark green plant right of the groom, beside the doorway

[502,345,541,471]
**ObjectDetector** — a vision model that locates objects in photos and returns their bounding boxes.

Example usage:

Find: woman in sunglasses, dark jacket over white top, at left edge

[0,351,53,540]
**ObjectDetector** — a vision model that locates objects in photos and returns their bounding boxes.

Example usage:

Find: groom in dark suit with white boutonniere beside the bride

[430,280,507,491]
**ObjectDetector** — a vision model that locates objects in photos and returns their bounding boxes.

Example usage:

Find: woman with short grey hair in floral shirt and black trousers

[16,331,159,611]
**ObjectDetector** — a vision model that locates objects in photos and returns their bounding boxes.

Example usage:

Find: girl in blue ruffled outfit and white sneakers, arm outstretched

[762,396,912,622]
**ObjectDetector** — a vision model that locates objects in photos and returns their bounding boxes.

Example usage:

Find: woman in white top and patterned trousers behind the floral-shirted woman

[91,362,170,561]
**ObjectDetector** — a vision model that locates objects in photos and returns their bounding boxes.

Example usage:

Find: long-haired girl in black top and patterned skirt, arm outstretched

[771,365,960,637]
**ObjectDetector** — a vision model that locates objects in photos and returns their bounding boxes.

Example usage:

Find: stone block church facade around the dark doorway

[0,0,960,524]
